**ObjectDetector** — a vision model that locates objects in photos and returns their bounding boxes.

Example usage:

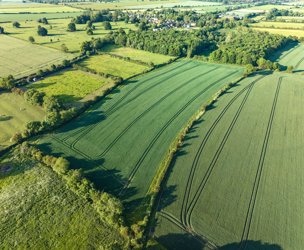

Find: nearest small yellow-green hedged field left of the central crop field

[27,69,114,103]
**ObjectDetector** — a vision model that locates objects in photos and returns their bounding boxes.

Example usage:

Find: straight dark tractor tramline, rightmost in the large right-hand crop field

[239,77,283,249]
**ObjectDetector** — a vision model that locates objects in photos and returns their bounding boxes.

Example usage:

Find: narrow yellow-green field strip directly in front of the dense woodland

[105,46,175,65]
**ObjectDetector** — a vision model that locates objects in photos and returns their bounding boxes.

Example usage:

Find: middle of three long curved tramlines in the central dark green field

[92,67,218,157]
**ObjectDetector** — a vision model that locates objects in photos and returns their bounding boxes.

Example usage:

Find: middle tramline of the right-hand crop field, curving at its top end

[185,76,265,232]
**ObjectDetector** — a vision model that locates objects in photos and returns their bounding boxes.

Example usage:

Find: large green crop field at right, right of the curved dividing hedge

[155,72,304,250]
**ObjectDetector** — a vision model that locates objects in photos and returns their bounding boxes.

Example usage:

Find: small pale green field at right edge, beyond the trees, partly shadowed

[270,44,304,72]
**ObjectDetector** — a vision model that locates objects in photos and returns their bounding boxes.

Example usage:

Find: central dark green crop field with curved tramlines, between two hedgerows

[37,60,244,208]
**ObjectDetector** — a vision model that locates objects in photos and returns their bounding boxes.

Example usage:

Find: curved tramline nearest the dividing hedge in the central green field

[121,71,238,193]
